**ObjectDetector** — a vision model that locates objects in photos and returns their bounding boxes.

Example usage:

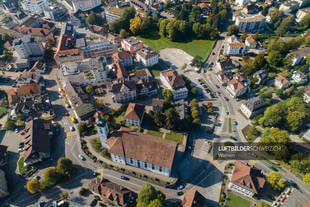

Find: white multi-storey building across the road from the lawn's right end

[224,35,249,56]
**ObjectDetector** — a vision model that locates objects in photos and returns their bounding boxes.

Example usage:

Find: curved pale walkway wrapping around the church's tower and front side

[83,135,177,183]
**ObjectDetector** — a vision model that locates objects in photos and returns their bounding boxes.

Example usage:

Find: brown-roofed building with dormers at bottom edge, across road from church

[88,178,138,207]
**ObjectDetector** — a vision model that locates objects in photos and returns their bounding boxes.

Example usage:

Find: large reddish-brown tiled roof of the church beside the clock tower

[107,127,178,169]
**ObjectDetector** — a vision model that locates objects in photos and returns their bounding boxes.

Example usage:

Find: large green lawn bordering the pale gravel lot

[138,34,215,60]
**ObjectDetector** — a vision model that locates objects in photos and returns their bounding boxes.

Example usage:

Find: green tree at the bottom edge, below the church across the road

[137,183,165,207]
